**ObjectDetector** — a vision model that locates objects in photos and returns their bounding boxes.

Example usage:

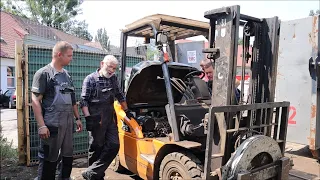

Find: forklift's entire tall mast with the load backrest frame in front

[203,6,290,179]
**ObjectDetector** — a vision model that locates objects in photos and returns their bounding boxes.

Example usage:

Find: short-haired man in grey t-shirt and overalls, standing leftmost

[31,41,82,180]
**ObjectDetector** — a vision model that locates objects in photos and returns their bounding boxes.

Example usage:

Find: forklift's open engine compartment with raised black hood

[124,61,211,143]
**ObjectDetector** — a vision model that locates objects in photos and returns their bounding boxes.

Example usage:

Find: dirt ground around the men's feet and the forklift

[1,143,320,180]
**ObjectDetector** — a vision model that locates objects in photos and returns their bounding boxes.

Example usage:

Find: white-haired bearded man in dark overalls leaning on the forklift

[80,55,132,180]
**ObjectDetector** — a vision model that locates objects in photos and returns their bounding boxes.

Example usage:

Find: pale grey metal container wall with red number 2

[276,15,320,150]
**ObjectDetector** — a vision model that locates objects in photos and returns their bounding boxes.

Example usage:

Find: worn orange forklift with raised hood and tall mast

[109,5,291,180]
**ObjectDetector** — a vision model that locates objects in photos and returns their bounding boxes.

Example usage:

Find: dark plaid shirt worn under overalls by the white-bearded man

[80,69,126,107]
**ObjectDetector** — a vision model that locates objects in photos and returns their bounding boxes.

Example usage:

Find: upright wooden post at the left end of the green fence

[15,41,26,164]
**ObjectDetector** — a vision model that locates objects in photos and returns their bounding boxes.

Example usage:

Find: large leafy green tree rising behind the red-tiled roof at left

[1,0,93,41]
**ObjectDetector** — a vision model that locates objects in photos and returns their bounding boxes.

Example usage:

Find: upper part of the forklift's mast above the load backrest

[203,6,280,106]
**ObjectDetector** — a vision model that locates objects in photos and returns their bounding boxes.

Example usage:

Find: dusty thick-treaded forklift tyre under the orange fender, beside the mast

[159,152,203,180]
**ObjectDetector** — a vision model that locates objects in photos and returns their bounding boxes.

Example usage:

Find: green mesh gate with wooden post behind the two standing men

[16,42,144,166]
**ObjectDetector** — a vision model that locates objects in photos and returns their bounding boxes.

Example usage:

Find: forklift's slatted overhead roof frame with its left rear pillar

[120,14,210,91]
